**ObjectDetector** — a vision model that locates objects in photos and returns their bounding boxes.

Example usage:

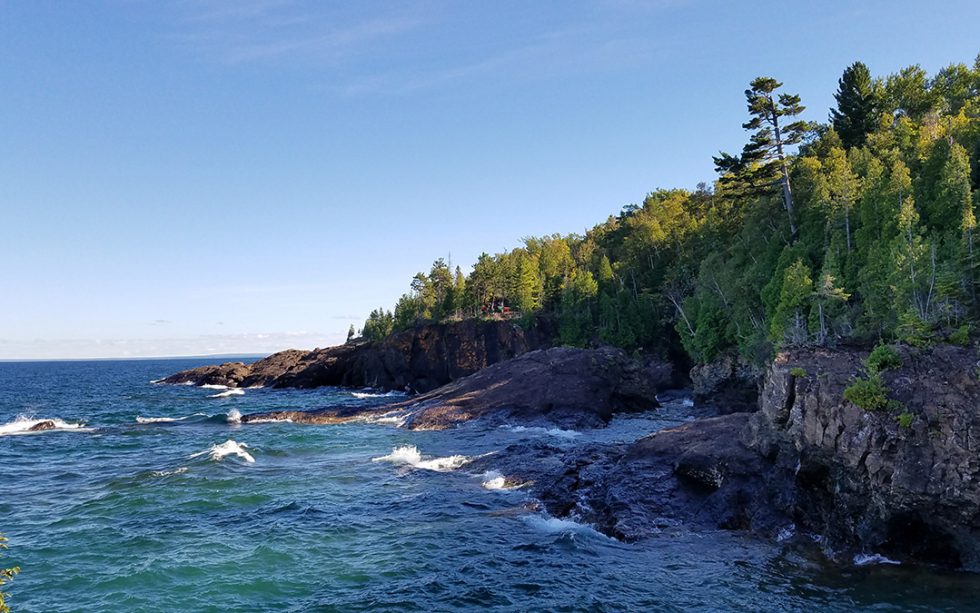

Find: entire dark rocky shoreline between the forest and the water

[166,330,980,570]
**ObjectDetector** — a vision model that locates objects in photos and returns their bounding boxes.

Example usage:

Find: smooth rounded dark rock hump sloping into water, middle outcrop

[242,347,673,430]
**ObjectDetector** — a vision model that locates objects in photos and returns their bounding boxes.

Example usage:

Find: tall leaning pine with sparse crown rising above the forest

[714,77,810,237]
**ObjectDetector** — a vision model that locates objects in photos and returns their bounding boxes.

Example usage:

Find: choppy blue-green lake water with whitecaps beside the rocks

[0,360,980,612]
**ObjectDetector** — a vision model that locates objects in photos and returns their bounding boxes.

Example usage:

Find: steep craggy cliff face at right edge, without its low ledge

[742,346,980,568]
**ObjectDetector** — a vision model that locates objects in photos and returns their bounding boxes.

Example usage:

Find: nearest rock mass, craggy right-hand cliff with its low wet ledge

[528,346,980,569]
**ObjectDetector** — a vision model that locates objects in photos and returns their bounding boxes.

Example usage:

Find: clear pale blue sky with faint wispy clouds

[0,0,980,359]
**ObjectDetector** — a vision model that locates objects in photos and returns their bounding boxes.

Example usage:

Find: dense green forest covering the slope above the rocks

[361,56,980,363]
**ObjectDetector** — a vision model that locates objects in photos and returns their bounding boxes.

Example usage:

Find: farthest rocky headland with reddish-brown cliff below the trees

[162,319,554,392]
